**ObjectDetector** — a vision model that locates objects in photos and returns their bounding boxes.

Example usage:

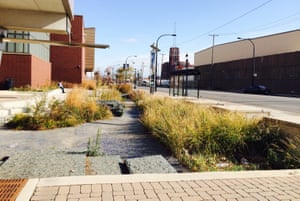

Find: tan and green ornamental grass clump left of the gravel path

[6,88,112,130]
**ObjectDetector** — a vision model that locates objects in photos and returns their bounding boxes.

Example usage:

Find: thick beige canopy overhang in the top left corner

[0,0,73,34]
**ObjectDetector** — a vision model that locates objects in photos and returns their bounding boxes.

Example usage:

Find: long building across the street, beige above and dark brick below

[194,30,300,94]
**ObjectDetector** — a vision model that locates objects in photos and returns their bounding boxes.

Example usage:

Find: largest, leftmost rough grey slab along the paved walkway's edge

[0,151,85,179]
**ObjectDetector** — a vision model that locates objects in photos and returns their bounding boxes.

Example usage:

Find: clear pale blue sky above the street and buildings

[74,0,300,75]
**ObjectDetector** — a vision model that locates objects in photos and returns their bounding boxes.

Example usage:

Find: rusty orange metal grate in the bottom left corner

[0,179,27,201]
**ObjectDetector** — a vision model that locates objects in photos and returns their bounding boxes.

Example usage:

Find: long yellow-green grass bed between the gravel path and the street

[137,96,300,171]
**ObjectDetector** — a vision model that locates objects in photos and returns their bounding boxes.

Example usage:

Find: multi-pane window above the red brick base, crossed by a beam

[6,31,30,53]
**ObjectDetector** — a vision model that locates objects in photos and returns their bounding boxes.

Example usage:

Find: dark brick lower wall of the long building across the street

[196,52,300,94]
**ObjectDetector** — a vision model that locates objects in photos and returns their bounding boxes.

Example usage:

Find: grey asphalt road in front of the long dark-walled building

[146,88,300,115]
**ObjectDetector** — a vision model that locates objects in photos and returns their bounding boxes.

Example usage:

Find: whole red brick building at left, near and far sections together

[0,16,94,88]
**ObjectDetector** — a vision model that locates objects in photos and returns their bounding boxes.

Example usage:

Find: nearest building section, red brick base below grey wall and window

[0,31,51,89]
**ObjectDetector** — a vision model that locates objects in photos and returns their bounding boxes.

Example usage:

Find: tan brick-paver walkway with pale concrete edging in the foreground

[17,170,300,201]
